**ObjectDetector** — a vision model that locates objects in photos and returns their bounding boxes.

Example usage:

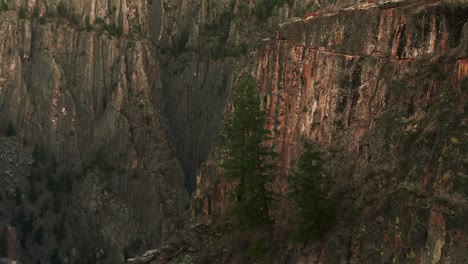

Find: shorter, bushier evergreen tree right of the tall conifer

[288,142,335,241]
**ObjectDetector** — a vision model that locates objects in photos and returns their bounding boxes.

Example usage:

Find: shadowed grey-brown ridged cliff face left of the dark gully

[0,1,188,263]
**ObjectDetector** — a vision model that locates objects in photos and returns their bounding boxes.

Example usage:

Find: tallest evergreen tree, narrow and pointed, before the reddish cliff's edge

[223,76,276,229]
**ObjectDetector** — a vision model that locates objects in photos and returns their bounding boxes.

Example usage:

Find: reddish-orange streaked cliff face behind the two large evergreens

[198,1,468,263]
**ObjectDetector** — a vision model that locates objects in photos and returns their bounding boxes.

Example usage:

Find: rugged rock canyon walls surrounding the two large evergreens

[0,0,468,263]
